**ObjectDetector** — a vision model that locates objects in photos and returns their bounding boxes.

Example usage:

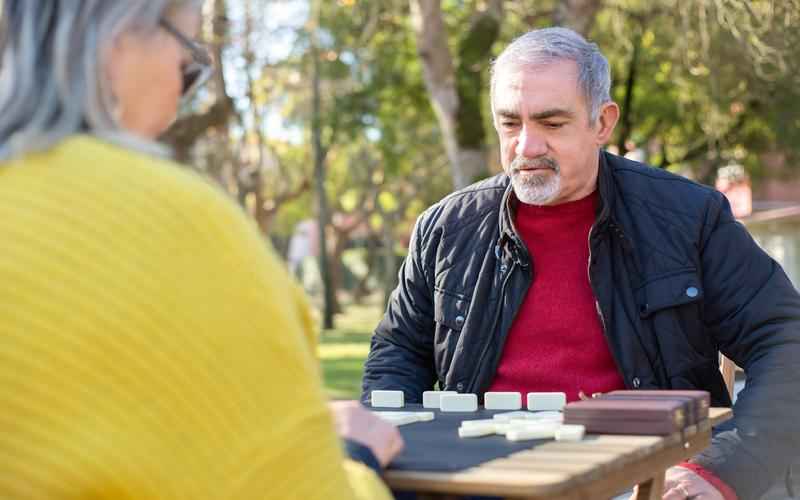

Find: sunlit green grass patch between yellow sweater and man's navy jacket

[318,301,383,399]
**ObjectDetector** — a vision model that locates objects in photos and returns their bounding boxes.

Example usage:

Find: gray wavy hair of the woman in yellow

[0,0,202,161]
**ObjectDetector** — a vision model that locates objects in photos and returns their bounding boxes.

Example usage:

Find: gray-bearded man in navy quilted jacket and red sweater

[363,28,800,499]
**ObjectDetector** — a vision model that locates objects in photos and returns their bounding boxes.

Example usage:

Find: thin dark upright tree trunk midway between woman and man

[311,0,334,329]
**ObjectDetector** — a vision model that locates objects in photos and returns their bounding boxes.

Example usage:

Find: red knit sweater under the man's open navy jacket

[489,192,625,401]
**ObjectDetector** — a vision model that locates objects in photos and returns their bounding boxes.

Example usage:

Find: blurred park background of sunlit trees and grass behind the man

[165,0,800,398]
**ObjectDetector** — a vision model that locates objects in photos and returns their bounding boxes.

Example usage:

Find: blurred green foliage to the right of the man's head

[595,0,800,183]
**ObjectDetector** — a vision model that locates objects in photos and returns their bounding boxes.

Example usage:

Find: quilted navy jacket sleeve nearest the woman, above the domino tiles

[361,212,436,403]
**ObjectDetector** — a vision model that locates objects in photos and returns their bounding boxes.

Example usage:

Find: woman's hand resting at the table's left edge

[328,401,403,467]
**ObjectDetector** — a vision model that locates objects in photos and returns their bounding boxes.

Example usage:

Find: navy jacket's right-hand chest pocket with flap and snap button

[635,268,716,380]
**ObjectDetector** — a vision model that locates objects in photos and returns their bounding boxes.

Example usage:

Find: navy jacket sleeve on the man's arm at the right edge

[692,194,800,499]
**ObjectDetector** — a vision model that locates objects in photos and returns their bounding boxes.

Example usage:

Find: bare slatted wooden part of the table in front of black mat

[385,408,733,500]
